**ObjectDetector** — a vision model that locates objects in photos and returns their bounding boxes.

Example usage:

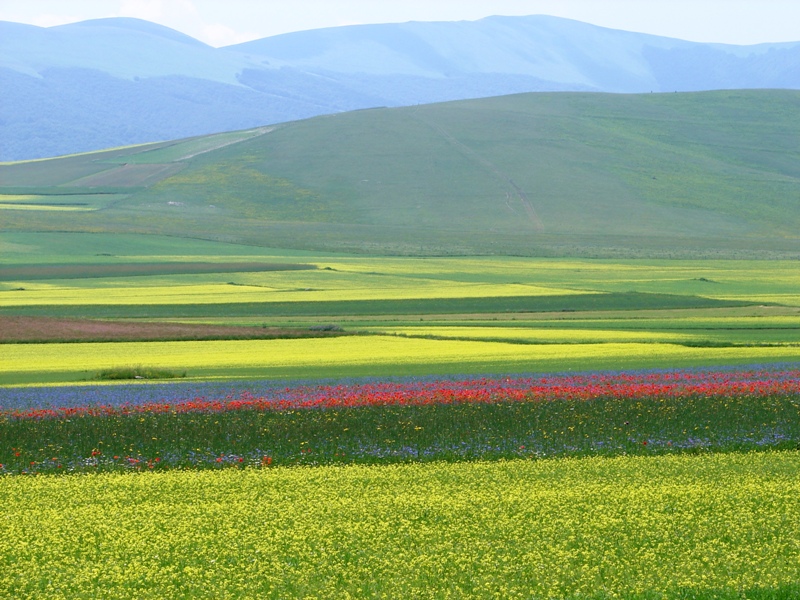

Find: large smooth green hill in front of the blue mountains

[0,90,800,257]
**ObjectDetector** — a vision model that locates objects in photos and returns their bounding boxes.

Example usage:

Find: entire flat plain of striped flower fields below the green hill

[0,233,800,600]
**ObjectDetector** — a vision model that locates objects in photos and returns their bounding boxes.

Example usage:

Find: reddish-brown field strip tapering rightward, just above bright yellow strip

[0,316,348,344]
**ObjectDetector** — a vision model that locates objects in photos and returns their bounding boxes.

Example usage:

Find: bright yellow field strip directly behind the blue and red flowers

[6,336,800,377]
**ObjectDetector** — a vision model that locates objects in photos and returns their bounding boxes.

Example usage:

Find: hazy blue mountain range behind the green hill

[0,16,800,160]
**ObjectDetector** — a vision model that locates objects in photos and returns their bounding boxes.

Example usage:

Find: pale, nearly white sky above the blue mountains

[0,0,800,47]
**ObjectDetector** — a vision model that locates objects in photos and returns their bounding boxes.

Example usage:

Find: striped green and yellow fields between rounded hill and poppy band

[0,233,800,384]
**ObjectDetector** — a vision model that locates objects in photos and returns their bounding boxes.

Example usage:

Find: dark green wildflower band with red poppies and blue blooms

[0,369,800,474]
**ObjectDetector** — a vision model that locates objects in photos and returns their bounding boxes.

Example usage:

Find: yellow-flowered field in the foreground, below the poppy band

[0,452,800,600]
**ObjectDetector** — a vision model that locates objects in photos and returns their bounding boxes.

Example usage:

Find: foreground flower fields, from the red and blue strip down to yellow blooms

[6,367,800,600]
